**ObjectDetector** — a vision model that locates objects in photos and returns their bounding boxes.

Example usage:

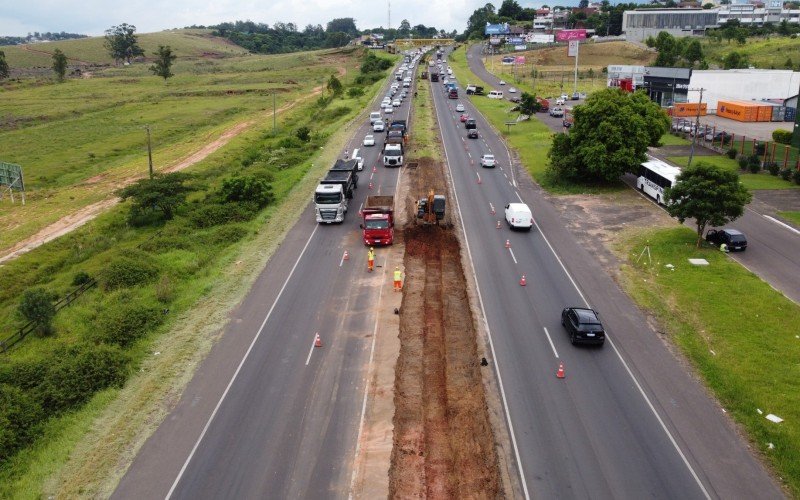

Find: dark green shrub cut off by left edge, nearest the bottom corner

[0,384,44,463]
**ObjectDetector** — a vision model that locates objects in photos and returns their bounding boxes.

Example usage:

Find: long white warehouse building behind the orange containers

[688,69,800,111]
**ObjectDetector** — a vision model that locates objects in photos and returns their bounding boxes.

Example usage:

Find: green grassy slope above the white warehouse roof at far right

[701,37,800,70]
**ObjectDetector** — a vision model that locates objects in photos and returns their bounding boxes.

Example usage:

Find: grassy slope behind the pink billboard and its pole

[484,42,656,98]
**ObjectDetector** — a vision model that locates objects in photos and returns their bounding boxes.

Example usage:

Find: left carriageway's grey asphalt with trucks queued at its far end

[113,55,413,500]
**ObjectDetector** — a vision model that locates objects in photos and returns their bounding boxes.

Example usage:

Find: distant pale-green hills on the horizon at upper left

[0,29,248,71]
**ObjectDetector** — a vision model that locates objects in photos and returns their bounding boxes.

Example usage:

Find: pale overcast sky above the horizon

[0,0,520,36]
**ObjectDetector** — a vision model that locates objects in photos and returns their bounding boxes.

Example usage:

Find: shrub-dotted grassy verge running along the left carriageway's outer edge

[0,42,400,498]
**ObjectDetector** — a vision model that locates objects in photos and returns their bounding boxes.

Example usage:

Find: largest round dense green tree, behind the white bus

[548,88,670,184]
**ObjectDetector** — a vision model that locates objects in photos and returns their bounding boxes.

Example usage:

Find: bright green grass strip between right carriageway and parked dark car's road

[616,228,800,496]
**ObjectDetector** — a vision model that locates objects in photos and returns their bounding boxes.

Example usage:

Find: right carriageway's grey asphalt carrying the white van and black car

[438,46,782,499]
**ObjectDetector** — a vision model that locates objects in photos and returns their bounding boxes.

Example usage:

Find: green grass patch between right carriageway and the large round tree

[449,44,626,194]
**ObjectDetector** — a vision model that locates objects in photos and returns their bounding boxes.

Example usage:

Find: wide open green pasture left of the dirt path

[0,32,366,250]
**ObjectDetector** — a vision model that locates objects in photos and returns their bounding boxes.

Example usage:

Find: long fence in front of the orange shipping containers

[671,118,800,170]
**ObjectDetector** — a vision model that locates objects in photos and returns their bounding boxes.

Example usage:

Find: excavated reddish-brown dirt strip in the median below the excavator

[389,158,502,498]
